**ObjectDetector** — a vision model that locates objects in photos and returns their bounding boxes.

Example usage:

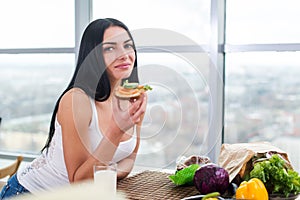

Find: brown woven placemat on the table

[117,171,199,200]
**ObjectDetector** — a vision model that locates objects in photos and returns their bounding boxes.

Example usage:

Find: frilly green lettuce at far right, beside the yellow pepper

[250,154,300,196]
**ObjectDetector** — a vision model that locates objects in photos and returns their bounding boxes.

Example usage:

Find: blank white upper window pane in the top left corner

[0,0,75,48]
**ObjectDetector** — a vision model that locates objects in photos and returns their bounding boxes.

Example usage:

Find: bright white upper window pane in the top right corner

[226,0,300,44]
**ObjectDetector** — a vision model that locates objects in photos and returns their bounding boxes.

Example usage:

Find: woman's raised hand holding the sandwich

[112,93,147,132]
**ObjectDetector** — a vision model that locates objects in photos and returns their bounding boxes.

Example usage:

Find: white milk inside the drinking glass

[94,169,117,195]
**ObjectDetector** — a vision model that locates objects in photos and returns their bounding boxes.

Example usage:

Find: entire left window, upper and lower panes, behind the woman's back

[0,0,75,154]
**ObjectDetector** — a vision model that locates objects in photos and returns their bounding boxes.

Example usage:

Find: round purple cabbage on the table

[193,163,229,194]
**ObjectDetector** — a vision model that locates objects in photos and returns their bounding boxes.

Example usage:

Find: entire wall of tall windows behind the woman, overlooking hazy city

[0,0,300,171]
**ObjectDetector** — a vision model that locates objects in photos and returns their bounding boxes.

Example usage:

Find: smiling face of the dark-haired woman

[102,26,135,82]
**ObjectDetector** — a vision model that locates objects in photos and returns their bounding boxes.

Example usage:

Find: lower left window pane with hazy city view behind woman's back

[0,54,75,153]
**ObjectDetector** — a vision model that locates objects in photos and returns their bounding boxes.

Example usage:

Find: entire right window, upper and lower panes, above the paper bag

[224,0,300,171]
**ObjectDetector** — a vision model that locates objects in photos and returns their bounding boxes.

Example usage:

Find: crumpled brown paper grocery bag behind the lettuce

[218,142,291,182]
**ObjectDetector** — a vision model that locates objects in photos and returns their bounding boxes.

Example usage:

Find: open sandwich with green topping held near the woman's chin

[115,80,152,99]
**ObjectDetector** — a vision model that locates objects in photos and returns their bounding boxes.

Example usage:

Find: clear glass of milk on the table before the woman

[94,162,117,196]
